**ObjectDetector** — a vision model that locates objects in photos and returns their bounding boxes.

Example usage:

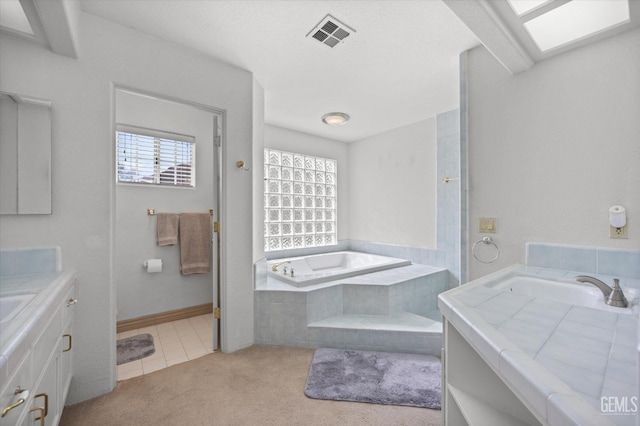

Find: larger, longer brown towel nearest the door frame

[180,213,211,275]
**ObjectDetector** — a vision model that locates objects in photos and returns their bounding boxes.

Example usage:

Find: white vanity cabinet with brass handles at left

[0,282,76,426]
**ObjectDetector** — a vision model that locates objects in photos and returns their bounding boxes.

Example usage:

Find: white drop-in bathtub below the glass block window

[267,251,411,287]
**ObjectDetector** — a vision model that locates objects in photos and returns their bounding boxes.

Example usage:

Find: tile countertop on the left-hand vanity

[0,269,76,383]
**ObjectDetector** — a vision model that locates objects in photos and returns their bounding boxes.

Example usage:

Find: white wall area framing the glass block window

[262,125,351,241]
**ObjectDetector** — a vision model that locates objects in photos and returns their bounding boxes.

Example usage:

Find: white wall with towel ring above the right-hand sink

[467,29,640,279]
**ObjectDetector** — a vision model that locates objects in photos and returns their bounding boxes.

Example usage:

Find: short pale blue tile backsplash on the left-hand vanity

[0,247,62,277]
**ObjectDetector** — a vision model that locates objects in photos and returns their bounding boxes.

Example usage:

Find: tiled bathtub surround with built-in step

[255,265,447,355]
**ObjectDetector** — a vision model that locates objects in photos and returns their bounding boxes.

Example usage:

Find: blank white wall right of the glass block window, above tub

[348,118,437,249]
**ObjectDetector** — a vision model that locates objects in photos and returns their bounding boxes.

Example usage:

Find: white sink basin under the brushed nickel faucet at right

[491,276,638,314]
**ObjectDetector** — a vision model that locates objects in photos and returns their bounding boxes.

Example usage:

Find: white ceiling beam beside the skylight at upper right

[443,0,534,74]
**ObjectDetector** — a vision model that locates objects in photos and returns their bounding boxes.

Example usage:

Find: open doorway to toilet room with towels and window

[113,87,224,380]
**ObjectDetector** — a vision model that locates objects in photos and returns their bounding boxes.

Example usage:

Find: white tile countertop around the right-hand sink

[438,265,640,426]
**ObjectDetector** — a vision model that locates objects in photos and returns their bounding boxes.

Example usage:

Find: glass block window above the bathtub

[264,149,338,251]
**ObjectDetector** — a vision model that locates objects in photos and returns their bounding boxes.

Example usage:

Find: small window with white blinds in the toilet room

[116,125,196,188]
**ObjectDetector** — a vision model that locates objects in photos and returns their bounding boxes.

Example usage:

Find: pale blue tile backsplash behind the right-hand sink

[527,243,640,279]
